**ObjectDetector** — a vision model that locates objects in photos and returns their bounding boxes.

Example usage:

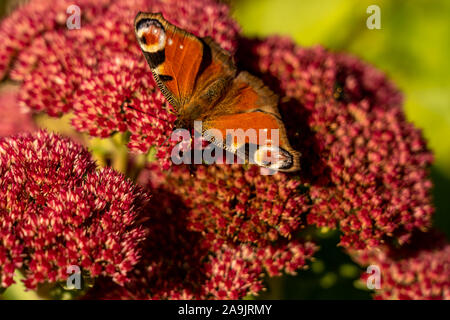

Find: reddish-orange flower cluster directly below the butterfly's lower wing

[150,164,309,244]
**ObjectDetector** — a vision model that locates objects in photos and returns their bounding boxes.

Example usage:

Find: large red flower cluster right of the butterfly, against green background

[239,38,433,249]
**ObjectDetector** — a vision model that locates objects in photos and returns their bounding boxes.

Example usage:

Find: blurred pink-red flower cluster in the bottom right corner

[354,232,450,300]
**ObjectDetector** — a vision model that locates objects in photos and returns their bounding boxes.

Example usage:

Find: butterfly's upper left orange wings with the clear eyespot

[134,12,235,115]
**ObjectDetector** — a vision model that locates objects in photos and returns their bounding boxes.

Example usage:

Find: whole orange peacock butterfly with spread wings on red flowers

[134,12,300,172]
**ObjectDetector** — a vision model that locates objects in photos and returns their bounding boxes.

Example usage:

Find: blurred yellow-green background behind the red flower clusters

[0,0,450,299]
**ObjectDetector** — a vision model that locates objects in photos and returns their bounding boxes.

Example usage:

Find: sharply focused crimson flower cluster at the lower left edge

[0,131,146,288]
